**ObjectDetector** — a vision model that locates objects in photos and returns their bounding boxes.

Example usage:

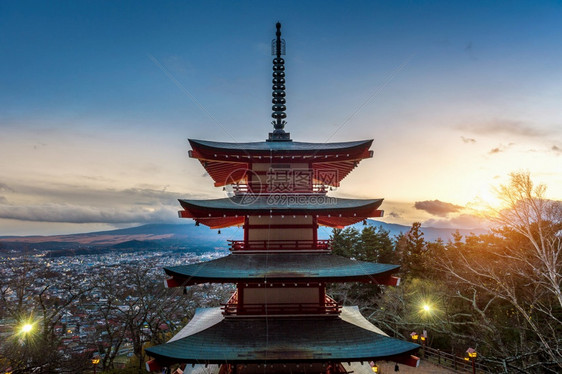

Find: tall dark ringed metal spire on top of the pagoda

[267,22,291,142]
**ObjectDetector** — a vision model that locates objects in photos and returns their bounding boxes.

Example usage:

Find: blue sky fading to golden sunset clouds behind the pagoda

[0,0,562,235]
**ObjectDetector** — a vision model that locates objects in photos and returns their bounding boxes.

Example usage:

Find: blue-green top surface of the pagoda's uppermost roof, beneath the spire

[189,139,373,154]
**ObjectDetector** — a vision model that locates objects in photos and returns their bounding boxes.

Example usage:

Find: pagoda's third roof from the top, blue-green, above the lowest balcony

[164,252,400,286]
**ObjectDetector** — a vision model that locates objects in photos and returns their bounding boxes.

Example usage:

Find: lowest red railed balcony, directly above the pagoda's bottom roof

[222,291,341,316]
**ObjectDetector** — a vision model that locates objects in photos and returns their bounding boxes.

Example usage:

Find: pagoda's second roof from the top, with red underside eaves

[179,194,383,228]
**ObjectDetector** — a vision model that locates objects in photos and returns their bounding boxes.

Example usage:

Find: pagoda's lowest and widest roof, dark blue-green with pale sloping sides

[146,307,419,364]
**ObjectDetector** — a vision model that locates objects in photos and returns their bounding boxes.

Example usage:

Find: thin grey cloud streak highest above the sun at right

[459,119,550,138]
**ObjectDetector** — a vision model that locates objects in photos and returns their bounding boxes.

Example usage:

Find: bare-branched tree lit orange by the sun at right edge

[436,173,562,372]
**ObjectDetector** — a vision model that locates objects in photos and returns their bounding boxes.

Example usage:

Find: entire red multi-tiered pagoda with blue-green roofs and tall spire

[146,23,419,374]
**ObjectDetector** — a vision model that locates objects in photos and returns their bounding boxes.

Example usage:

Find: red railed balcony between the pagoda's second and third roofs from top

[228,240,332,252]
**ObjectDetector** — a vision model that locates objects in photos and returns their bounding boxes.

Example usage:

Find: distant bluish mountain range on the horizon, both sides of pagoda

[0,220,485,254]
